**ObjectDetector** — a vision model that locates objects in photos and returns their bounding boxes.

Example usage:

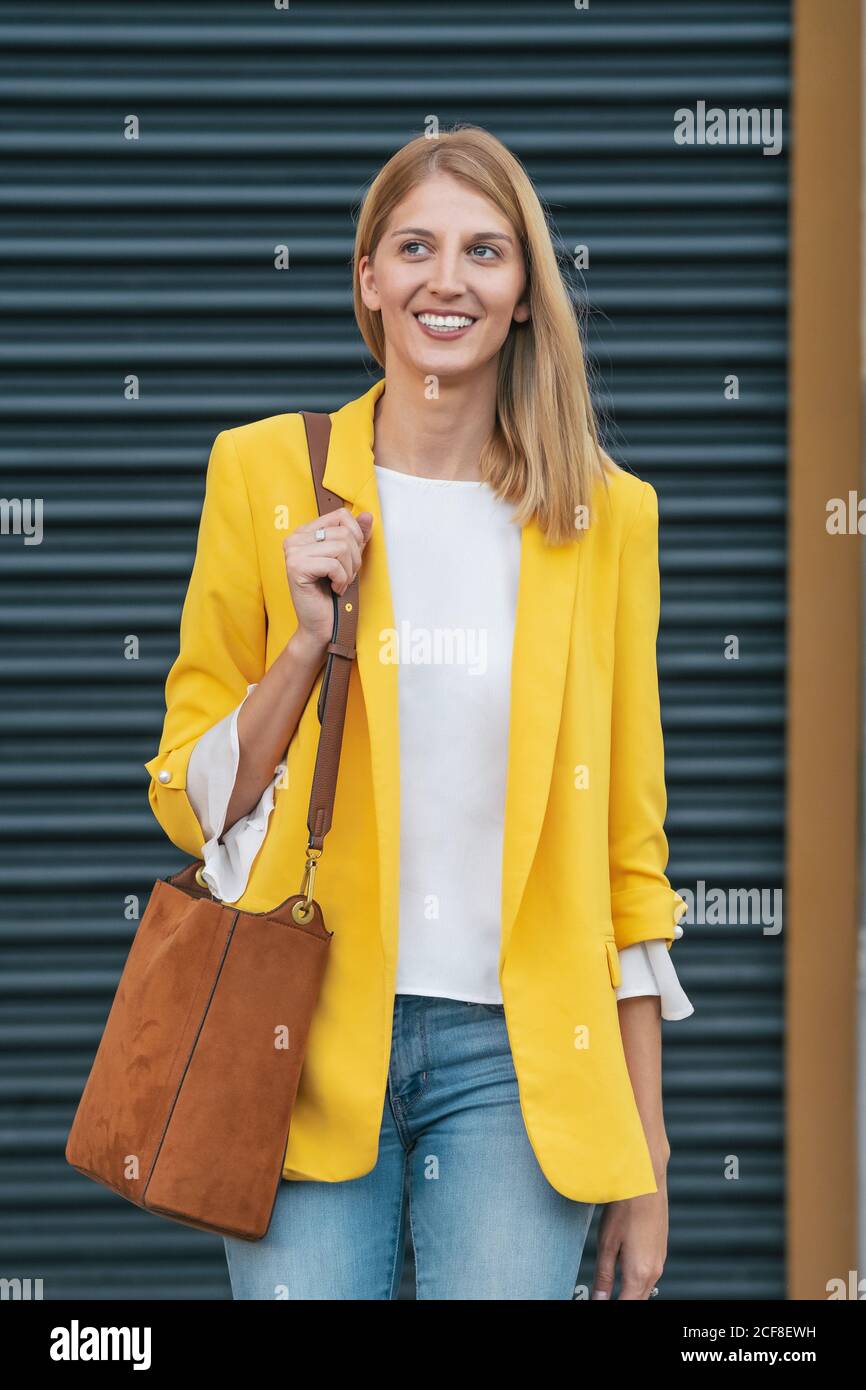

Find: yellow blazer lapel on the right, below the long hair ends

[499,521,582,974]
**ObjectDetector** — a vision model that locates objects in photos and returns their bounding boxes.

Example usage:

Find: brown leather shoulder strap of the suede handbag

[300,410,359,849]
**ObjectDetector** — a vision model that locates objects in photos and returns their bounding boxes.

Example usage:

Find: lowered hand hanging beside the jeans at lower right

[591,1165,667,1300]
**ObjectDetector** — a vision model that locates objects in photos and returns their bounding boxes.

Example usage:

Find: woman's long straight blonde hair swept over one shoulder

[353,125,617,545]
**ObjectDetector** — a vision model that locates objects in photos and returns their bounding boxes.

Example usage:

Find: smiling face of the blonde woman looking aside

[359,174,530,379]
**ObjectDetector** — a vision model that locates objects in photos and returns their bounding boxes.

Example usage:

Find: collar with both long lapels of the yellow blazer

[324,379,584,973]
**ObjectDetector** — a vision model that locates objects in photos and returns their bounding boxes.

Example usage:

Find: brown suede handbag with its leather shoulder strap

[65,411,359,1240]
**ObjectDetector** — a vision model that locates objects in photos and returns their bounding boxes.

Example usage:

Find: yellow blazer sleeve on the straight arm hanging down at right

[609,482,688,949]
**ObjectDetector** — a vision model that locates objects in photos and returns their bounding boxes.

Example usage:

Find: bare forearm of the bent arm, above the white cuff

[224,628,327,831]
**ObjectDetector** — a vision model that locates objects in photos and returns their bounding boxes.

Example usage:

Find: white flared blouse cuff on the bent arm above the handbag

[186,684,282,902]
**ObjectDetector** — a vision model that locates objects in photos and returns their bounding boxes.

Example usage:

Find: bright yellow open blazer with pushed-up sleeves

[145,381,687,1202]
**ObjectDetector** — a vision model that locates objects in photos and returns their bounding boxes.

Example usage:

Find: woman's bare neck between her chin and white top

[374,359,496,482]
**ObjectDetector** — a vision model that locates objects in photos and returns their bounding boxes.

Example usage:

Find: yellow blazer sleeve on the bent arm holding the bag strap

[145,431,267,858]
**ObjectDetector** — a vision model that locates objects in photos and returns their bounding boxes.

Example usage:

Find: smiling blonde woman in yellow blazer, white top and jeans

[146,128,692,1300]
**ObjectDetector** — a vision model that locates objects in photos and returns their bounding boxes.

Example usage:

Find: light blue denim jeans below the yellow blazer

[225,994,594,1301]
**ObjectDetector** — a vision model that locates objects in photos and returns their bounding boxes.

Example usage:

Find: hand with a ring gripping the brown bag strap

[282,507,373,649]
